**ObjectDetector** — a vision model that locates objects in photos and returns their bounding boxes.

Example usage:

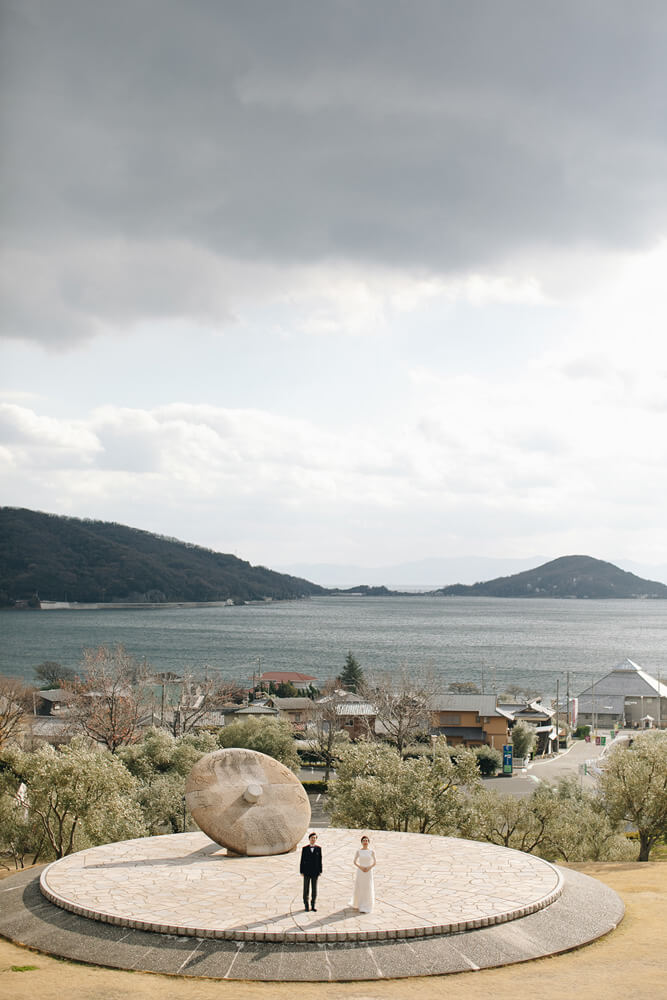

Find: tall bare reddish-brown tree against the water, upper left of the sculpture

[70,645,153,753]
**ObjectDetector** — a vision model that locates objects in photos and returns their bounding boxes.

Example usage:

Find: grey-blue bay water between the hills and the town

[0,596,667,695]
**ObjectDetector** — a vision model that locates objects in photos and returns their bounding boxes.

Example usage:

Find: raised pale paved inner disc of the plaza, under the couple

[40,829,562,943]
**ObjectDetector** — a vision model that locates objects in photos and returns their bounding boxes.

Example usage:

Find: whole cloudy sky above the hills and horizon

[0,0,667,582]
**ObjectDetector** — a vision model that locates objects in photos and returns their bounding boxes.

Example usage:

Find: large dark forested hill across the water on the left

[0,507,326,606]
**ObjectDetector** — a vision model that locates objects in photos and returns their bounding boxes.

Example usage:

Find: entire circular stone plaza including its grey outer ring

[0,828,623,981]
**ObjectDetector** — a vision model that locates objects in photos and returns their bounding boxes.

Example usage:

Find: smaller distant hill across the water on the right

[435,556,667,598]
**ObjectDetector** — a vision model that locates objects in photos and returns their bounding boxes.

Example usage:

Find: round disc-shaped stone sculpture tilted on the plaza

[185,747,310,856]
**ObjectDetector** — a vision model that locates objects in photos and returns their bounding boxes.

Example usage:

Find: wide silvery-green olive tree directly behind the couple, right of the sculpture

[328,739,479,834]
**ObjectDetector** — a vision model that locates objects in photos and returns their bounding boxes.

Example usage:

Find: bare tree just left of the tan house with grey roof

[360,666,435,752]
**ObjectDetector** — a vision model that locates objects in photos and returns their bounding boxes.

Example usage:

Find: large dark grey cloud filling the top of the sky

[0,0,667,339]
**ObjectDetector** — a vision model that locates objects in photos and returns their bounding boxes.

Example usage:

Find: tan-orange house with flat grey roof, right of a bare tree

[428,694,512,750]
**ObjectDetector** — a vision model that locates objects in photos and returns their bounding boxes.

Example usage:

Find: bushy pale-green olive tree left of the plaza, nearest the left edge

[4,736,146,858]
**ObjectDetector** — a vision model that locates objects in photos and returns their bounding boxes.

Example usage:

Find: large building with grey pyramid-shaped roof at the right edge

[577,659,667,729]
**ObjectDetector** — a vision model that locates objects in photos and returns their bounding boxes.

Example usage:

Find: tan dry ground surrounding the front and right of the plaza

[0,862,667,1000]
